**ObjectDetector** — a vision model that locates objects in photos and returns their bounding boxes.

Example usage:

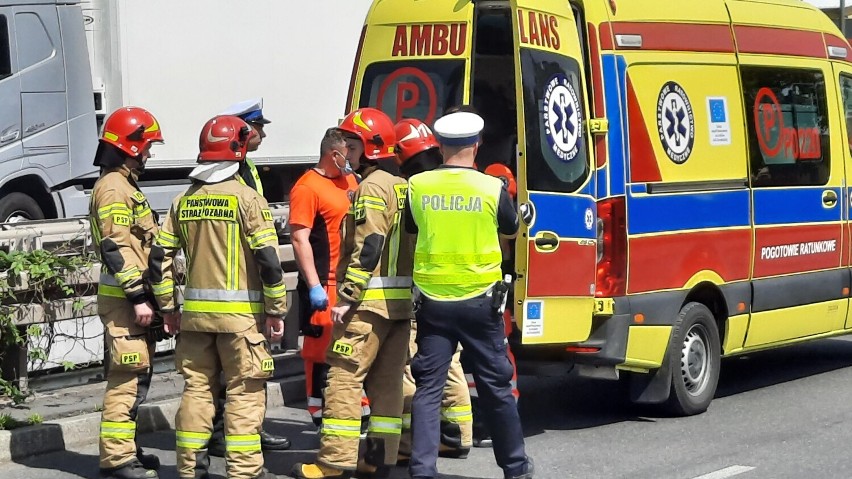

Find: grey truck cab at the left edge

[0,0,97,222]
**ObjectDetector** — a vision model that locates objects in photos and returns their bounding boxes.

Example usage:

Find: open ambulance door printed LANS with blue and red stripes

[510,0,597,344]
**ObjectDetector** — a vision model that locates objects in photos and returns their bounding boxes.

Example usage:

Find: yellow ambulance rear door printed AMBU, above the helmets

[347,0,474,126]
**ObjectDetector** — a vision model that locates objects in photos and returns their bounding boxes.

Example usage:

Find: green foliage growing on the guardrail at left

[0,246,94,404]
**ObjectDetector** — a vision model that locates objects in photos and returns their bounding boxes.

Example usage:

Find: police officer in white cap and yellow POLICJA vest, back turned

[406,112,533,479]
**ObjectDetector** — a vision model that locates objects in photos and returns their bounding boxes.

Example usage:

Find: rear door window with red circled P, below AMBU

[359,60,465,126]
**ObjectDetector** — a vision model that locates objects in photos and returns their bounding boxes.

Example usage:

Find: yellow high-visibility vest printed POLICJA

[408,168,503,301]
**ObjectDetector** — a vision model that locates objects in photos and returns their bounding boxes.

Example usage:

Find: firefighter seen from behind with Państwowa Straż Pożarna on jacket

[150,116,287,478]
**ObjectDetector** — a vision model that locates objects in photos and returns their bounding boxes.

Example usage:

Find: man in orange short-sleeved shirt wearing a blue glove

[289,128,369,428]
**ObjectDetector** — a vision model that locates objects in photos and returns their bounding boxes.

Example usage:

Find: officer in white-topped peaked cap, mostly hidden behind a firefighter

[203,98,290,457]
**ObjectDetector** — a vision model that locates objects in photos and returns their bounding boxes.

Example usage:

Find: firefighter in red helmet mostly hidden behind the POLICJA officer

[394,119,473,464]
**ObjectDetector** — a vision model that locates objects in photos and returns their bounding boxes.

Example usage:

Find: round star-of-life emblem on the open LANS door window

[542,73,583,162]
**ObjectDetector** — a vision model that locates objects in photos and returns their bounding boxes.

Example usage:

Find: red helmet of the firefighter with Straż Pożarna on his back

[198,115,257,162]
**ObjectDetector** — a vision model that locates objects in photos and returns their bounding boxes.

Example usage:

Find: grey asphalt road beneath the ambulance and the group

[8,339,852,479]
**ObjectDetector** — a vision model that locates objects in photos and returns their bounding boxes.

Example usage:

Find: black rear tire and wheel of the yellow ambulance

[666,302,722,416]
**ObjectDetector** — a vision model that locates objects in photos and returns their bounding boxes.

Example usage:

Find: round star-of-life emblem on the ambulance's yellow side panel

[657,81,695,164]
